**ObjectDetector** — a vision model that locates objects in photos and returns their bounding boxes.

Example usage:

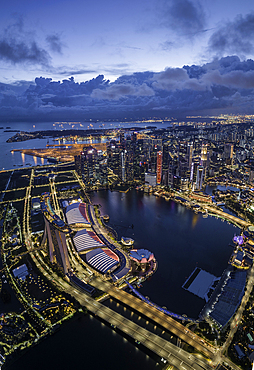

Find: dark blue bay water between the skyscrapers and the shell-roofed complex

[91,190,238,318]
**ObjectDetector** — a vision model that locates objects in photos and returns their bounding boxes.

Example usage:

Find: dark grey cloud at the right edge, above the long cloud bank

[208,13,254,56]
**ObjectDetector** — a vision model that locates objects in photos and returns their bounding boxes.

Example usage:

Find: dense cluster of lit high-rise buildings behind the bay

[75,122,254,191]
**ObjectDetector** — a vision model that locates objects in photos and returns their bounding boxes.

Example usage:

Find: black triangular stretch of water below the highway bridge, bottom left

[4,315,161,370]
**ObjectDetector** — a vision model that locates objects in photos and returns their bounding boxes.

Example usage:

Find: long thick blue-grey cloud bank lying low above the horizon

[0,56,254,122]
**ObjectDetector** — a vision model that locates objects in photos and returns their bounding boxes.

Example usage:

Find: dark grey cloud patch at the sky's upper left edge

[0,18,51,66]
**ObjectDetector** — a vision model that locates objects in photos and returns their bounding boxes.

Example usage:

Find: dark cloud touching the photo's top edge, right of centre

[160,0,206,38]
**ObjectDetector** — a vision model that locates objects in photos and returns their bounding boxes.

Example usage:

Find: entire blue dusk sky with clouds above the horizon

[0,0,254,121]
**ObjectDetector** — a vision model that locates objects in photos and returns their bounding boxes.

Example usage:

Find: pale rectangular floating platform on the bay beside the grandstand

[182,267,220,302]
